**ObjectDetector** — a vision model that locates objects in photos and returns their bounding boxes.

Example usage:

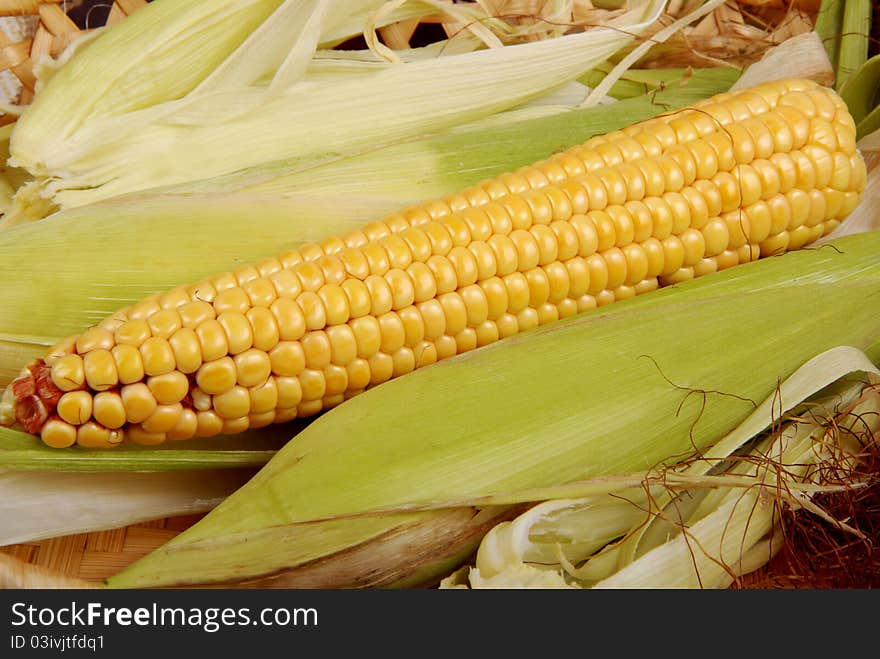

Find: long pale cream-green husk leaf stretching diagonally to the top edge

[12,0,664,207]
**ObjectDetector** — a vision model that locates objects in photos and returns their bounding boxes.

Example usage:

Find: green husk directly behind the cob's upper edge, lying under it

[0,78,727,387]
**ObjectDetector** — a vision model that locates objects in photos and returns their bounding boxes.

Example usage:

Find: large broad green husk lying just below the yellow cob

[107,232,880,588]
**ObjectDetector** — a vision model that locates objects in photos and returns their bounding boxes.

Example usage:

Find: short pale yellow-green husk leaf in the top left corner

[12,0,281,162]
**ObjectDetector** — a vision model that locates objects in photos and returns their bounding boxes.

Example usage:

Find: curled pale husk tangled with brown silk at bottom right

[442,346,880,588]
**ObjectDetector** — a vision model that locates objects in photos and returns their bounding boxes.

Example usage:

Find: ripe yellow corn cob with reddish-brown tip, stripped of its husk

[0,80,866,447]
